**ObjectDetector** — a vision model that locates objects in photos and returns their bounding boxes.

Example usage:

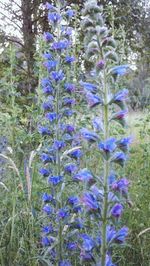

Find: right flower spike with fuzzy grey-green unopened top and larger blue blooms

[75,0,131,266]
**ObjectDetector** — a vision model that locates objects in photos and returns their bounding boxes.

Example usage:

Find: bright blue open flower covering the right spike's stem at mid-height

[98,138,117,159]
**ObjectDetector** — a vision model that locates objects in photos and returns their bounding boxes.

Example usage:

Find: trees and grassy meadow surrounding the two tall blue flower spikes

[0,0,150,266]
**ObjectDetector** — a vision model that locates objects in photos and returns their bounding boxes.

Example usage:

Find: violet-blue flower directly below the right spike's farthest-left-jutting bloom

[81,192,99,211]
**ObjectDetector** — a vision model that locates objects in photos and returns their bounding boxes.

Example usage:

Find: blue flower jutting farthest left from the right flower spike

[73,169,94,185]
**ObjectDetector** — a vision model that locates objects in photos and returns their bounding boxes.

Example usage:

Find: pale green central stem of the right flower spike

[101,69,109,266]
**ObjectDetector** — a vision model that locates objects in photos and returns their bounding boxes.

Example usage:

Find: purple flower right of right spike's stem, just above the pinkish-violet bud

[111,178,129,195]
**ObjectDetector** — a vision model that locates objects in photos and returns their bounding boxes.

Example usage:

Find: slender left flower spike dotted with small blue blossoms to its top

[38,0,82,266]
